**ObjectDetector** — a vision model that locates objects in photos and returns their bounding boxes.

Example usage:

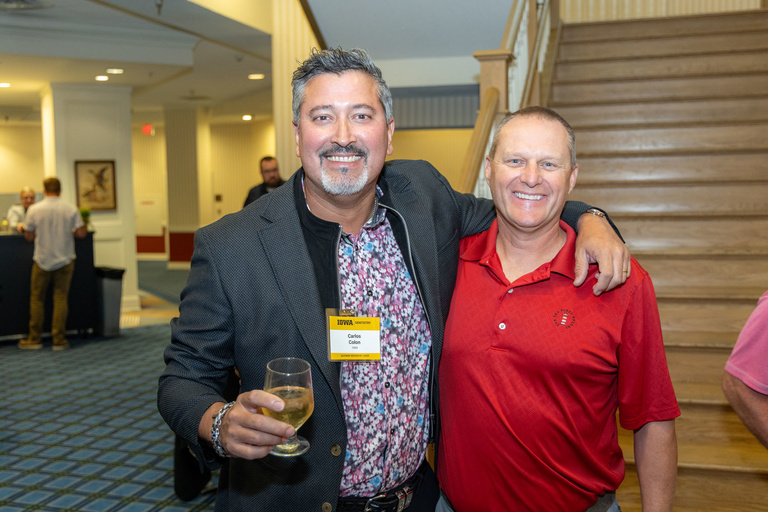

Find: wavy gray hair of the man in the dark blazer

[291,48,392,125]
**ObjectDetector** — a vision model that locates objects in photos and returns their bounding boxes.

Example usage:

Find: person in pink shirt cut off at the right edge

[723,291,768,448]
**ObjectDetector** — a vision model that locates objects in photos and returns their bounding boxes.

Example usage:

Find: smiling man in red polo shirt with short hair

[437,107,680,512]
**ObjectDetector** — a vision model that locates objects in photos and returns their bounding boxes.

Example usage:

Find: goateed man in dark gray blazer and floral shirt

[158,49,629,512]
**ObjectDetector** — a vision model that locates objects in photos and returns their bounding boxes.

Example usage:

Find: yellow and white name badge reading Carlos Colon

[327,311,381,361]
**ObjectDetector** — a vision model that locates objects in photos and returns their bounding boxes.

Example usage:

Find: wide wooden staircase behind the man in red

[549,11,768,512]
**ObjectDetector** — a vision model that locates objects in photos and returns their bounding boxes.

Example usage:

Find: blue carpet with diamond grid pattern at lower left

[0,325,215,512]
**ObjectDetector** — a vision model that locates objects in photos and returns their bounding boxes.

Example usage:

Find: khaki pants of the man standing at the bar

[28,261,75,345]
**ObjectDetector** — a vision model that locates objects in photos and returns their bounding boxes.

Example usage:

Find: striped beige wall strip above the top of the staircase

[560,0,761,23]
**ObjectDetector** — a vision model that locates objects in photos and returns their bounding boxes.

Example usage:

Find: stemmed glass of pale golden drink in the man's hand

[262,357,315,457]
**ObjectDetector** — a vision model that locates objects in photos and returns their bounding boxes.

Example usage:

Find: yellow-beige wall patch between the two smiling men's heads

[388,129,472,188]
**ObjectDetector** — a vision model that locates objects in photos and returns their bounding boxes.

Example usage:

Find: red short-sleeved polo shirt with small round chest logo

[438,222,680,512]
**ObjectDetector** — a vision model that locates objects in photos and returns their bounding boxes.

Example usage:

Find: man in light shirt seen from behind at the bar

[18,178,87,350]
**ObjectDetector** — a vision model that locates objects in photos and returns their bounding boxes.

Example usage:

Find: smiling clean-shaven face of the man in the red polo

[485,115,578,233]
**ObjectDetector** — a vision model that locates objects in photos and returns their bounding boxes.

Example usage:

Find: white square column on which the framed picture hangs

[41,83,140,311]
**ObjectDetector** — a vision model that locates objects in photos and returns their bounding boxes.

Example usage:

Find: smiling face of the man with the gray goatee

[293,71,395,203]
